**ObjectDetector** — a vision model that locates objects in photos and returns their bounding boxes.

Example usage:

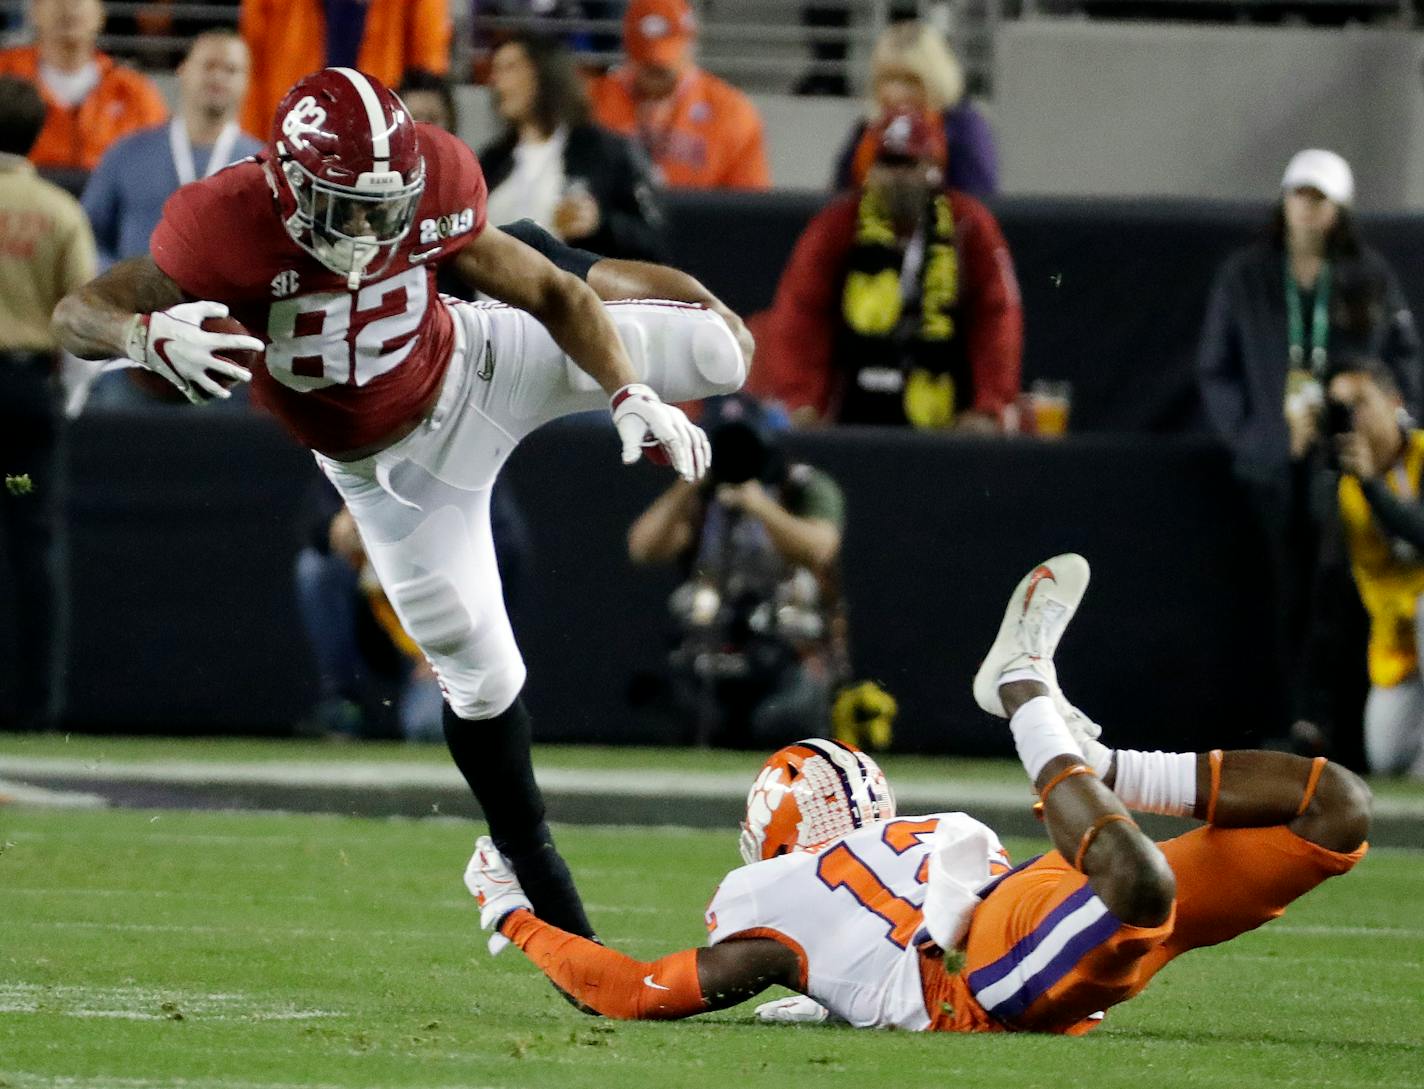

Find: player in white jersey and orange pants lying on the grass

[466,555,1370,1035]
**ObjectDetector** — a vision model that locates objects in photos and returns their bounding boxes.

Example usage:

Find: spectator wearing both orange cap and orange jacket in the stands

[590,0,772,189]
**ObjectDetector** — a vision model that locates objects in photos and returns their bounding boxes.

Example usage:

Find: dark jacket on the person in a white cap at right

[1196,242,1424,475]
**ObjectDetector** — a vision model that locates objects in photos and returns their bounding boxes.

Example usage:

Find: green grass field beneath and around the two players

[0,807,1424,1089]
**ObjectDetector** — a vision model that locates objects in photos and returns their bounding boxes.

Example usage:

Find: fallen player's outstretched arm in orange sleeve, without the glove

[498,908,799,1021]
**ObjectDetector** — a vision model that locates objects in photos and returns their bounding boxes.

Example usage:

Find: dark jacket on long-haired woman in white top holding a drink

[480,124,666,262]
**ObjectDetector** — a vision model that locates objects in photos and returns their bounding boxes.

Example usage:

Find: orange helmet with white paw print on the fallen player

[740,737,894,866]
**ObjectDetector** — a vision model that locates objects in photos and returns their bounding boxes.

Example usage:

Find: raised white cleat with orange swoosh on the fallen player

[974,552,1094,725]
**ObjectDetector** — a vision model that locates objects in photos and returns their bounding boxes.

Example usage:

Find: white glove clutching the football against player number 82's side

[124,302,262,404]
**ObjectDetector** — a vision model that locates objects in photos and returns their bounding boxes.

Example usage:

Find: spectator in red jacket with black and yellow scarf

[752,110,1024,434]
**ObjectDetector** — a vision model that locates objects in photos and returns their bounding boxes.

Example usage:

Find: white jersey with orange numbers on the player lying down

[706,813,1008,1032]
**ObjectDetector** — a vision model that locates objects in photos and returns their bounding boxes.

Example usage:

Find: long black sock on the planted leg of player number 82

[444,698,594,938]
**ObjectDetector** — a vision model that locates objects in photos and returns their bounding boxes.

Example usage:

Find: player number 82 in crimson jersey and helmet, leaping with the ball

[54,68,749,934]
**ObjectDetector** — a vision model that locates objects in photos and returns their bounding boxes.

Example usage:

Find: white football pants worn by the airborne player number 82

[316,300,746,719]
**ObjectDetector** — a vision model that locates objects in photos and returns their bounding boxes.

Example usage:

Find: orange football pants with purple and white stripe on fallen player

[927,826,1368,1035]
